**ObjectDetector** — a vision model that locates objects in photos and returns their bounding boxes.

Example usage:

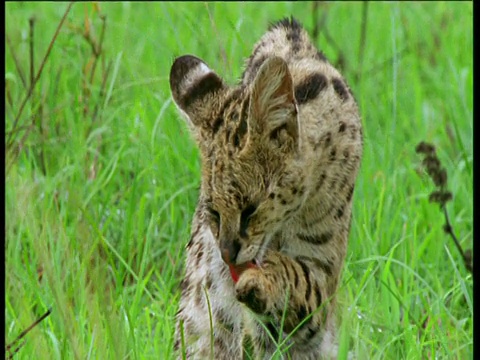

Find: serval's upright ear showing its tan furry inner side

[248,57,298,146]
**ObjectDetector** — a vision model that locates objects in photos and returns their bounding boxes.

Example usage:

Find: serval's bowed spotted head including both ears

[170,55,305,264]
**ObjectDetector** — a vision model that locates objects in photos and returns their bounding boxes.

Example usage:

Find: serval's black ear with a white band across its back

[170,55,225,126]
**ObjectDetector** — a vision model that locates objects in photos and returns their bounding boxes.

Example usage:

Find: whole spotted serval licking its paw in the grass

[170,18,362,360]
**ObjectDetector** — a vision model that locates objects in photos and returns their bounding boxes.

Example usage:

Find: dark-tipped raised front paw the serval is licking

[235,269,271,314]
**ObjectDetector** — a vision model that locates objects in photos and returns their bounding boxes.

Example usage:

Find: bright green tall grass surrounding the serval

[5,2,473,359]
